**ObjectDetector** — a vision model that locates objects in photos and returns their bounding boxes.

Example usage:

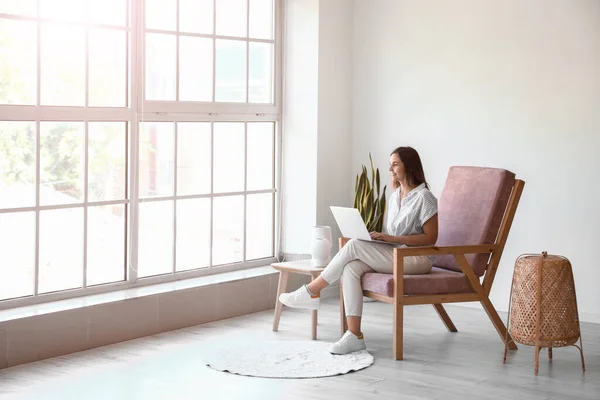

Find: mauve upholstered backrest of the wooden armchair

[433,166,515,276]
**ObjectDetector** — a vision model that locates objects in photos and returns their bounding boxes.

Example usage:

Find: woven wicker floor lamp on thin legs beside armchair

[504,252,585,375]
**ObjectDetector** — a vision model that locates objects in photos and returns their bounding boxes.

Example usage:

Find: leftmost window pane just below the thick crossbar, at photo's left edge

[0,122,36,209]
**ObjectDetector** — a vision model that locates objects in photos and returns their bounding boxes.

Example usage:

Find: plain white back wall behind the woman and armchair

[352,0,600,322]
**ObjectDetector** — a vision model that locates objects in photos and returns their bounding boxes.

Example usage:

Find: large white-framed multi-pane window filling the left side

[0,0,281,308]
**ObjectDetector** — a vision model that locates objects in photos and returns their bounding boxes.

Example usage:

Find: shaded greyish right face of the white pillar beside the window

[317,0,358,247]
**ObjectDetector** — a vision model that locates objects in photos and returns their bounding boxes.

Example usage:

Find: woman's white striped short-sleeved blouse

[385,183,438,236]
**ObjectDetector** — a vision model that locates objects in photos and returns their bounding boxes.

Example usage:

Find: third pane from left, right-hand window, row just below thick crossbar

[213,122,244,193]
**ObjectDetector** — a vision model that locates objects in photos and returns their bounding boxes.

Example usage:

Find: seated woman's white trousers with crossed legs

[321,239,431,317]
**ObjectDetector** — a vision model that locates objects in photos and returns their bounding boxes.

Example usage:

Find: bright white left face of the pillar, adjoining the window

[281,0,319,253]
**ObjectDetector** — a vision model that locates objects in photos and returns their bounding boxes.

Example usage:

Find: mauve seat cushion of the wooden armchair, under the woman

[362,267,473,297]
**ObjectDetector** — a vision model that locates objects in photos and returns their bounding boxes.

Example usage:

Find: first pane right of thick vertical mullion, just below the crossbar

[139,122,175,197]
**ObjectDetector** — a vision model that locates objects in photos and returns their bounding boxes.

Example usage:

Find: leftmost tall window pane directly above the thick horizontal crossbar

[0,18,37,104]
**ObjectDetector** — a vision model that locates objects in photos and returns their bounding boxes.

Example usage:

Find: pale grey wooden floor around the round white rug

[0,299,600,400]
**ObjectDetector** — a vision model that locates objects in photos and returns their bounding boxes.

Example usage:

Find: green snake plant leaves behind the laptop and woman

[354,153,387,232]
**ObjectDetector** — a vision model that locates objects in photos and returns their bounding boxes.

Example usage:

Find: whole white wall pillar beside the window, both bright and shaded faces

[282,0,353,254]
